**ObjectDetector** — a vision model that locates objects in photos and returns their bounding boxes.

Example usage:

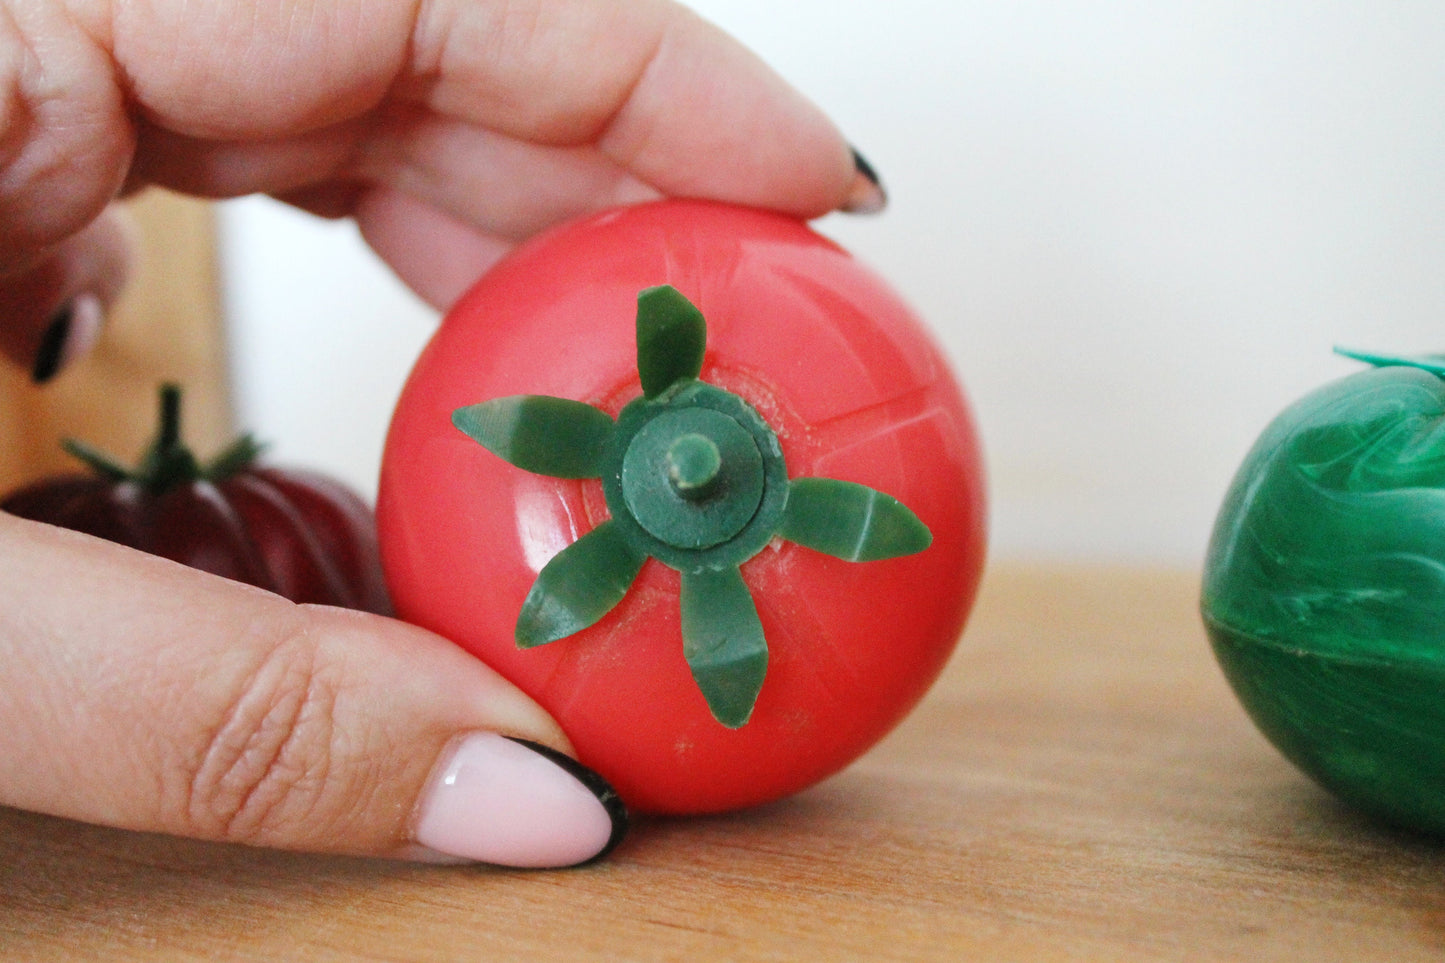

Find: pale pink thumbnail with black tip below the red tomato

[415,732,627,869]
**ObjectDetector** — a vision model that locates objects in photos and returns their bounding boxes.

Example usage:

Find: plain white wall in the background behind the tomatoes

[223,0,1445,565]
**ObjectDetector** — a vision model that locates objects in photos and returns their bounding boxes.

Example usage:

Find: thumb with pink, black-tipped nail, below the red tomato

[0,513,626,866]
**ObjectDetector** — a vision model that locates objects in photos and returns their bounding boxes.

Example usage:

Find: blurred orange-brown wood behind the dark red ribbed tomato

[0,189,231,492]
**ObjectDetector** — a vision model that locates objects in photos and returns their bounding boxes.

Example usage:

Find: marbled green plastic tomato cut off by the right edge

[1202,348,1445,833]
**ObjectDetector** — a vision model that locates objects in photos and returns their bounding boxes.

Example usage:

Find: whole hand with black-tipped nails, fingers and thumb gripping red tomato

[0,0,883,866]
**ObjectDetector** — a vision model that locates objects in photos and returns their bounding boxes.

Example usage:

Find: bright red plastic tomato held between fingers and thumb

[377,201,984,813]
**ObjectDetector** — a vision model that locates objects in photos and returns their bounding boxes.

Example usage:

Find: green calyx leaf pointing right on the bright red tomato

[777,479,933,561]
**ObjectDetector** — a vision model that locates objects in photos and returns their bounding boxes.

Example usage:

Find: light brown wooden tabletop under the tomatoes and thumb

[0,565,1445,963]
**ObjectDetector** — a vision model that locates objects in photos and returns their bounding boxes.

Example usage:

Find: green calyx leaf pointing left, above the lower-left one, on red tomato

[452,395,614,479]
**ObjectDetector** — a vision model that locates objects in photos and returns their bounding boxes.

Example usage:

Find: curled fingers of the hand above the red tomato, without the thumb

[0,0,884,375]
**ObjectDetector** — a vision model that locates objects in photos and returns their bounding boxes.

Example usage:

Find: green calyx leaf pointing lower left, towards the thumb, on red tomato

[516,522,647,649]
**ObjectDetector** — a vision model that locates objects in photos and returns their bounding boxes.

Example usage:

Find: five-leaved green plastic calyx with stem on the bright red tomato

[452,285,932,729]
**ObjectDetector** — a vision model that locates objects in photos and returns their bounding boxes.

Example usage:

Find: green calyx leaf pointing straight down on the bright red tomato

[682,568,767,729]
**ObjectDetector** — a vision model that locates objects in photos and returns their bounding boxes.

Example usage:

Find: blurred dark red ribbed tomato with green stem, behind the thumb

[0,385,392,615]
